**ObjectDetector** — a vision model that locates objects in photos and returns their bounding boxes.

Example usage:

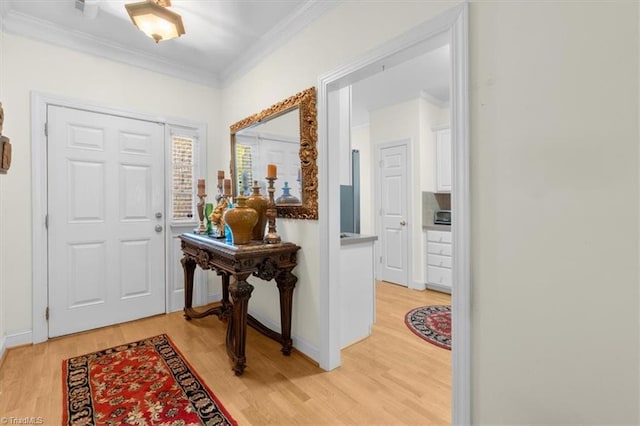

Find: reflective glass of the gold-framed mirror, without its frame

[235,107,302,205]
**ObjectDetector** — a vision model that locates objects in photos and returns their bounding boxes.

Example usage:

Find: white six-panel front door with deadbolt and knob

[47,105,165,337]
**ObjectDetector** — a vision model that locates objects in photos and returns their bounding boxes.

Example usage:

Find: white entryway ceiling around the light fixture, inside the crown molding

[0,0,336,86]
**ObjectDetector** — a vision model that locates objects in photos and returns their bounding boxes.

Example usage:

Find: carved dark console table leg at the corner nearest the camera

[227,273,253,376]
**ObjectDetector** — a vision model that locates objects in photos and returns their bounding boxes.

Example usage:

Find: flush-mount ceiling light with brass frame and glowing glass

[124,0,184,43]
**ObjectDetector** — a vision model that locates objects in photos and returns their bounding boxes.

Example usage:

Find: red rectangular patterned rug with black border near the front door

[62,334,237,426]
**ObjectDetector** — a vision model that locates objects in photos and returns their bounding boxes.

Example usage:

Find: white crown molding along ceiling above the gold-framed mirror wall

[218,0,342,87]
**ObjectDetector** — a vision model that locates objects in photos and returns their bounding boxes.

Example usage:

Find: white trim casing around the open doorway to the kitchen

[318,4,471,424]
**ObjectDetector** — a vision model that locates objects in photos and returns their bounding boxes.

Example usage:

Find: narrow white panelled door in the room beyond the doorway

[378,144,409,286]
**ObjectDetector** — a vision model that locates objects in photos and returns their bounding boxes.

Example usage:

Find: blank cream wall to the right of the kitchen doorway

[469,2,640,425]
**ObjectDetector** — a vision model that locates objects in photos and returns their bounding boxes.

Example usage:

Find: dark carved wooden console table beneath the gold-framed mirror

[180,233,300,376]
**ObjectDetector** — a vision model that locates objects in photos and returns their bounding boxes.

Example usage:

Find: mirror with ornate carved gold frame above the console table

[230,87,318,220]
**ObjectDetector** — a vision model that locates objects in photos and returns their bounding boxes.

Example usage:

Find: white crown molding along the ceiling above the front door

[0,6,218,87]
